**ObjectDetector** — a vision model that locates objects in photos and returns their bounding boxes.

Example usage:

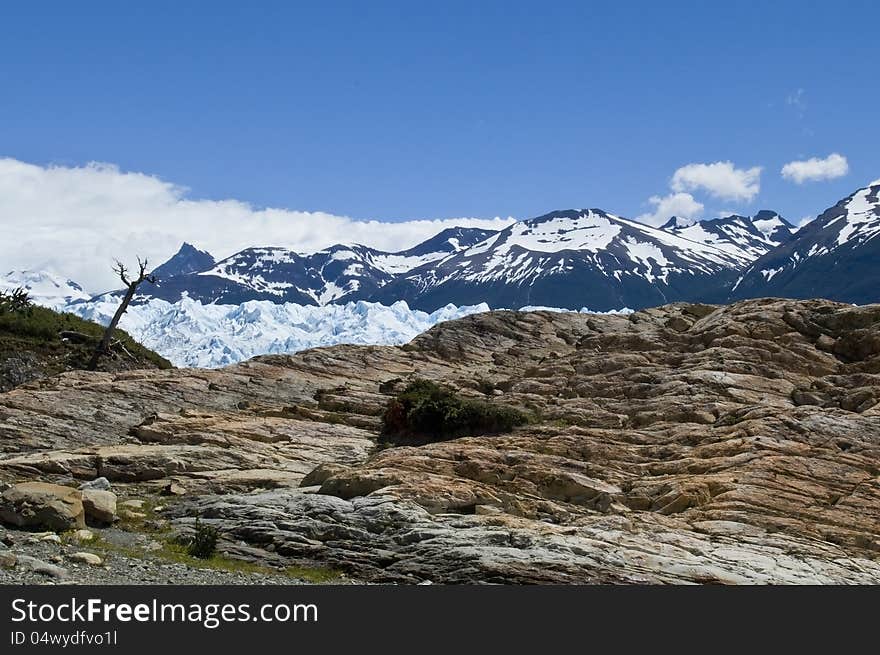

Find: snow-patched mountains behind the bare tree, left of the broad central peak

[122,228,502,305]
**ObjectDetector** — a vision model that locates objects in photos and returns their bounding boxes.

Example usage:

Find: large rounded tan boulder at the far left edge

[0,482,85,531]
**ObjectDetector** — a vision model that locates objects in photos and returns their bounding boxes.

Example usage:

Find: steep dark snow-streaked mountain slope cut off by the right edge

[732,180,880,304]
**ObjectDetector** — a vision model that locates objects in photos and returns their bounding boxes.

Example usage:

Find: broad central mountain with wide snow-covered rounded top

[360,209,744,311]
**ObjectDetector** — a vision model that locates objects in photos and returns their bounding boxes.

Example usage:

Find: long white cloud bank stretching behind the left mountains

[0,158,513,292]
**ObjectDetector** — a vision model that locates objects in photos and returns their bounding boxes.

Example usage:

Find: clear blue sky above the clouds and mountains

[0,1,880,284]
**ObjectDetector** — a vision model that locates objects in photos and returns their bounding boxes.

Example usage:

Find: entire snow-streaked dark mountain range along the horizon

[6,180,880,312]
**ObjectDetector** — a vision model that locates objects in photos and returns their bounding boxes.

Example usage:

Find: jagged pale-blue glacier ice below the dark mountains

[66,297,496,368]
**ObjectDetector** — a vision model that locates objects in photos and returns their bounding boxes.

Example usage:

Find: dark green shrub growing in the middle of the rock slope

[382,380,527,445]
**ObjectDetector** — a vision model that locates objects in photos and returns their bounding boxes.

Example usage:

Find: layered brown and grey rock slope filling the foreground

[0,299,880,584]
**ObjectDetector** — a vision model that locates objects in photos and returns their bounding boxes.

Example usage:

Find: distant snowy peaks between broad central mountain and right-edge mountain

[661,210,794,266]
